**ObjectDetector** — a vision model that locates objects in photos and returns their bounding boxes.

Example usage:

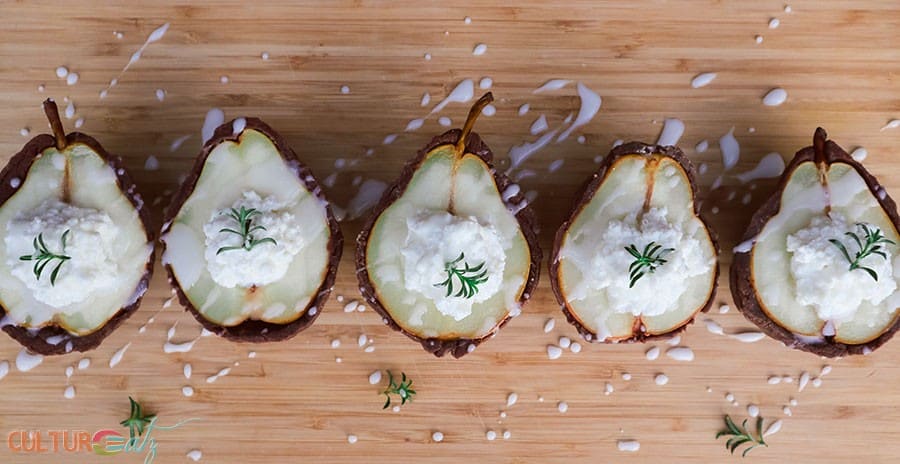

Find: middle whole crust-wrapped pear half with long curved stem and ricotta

[356,93,541,358]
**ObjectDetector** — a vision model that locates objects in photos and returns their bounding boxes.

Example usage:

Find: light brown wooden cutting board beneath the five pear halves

[0,0,900,464]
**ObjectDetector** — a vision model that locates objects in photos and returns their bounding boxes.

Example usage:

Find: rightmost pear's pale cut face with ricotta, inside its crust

[751,161,900,344]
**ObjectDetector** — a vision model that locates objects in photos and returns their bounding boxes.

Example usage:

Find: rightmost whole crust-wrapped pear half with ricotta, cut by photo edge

[731,128,900,357]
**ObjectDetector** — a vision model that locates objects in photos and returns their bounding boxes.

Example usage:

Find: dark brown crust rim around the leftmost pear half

[0,132,156,356]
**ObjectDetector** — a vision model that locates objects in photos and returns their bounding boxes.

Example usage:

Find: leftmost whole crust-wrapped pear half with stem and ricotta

[0,100,154,355]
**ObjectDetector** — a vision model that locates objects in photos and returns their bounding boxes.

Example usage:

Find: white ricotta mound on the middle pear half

[401,211,506,321]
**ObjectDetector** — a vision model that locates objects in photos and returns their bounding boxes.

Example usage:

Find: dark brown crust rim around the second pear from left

[160,118,344,343]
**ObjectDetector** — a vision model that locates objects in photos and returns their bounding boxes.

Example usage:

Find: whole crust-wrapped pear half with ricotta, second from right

[550,142,719,343]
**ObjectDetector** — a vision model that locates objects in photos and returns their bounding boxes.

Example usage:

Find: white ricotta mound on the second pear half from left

[203,191,307,288]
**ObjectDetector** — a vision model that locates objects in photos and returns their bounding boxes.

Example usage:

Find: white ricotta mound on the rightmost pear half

[787,212,897,324]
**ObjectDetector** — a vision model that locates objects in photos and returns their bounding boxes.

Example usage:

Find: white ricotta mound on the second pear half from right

[560,207,712,316]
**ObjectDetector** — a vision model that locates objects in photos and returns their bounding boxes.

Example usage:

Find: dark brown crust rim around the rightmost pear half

[729,136,900,358]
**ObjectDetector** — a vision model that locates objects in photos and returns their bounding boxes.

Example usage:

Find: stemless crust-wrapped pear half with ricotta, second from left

[161,118,343,342]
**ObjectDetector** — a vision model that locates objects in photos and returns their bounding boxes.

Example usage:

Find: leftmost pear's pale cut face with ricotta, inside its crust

[0,143,153,336]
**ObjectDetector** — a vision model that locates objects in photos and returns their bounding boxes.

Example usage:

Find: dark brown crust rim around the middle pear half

[356,129,541,358]
